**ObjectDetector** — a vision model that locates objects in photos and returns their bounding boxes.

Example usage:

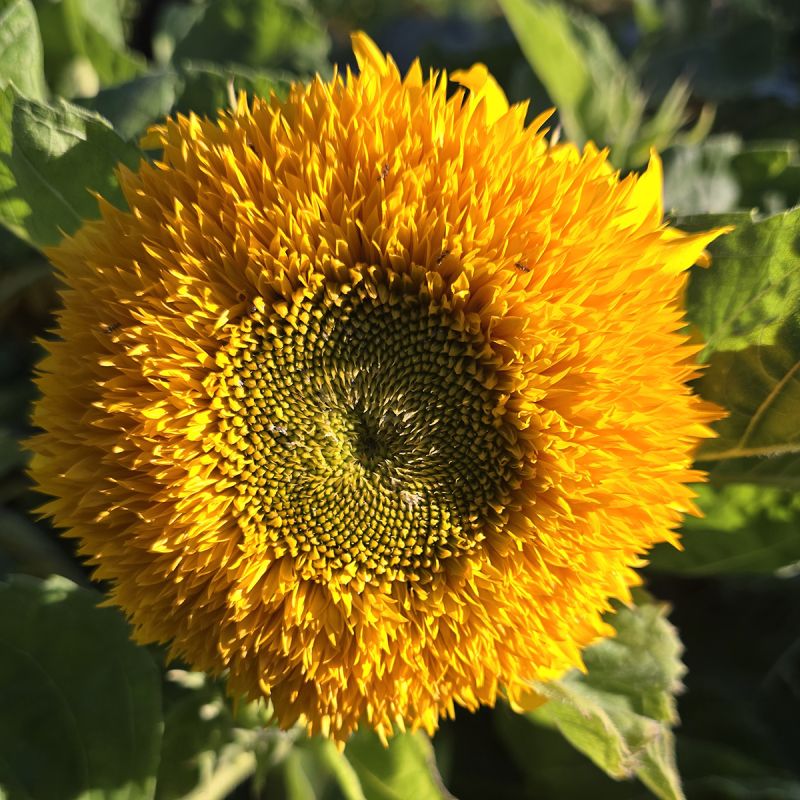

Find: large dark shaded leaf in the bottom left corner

[0,577,161,800]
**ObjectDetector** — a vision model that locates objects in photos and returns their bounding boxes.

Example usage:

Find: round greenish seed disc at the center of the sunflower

[214,266,519,583]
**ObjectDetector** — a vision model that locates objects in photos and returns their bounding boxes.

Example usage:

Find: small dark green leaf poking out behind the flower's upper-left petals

[173,61,292,117]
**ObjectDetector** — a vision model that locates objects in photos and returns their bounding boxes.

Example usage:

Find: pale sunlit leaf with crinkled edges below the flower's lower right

[510,604,684,800]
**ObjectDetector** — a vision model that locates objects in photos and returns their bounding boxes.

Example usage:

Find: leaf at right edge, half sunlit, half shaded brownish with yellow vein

[679,209,800,488]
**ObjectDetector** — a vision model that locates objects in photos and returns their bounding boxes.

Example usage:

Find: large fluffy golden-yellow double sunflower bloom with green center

[31,34,720,741]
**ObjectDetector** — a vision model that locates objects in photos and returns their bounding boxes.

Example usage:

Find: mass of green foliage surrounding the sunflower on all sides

[0,0,800,800]
